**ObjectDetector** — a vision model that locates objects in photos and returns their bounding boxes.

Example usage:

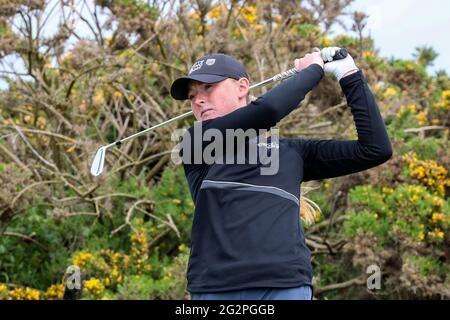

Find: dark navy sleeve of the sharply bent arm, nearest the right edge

[294,71,392,181]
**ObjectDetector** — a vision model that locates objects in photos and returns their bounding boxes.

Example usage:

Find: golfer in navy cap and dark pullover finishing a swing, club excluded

[171,47,392,300]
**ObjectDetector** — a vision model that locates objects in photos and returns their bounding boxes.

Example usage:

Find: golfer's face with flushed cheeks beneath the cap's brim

[188,78,249,121]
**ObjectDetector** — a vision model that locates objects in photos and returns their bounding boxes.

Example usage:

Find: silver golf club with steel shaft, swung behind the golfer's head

[91,48,348,177]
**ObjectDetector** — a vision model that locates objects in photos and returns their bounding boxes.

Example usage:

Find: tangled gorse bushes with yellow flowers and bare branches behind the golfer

[0,0,450,299]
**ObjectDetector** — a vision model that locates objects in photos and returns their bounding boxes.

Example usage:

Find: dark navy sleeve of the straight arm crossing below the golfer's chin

[182,64,324,163]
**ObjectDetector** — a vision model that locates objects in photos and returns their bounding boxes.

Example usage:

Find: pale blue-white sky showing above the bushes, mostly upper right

[0,0,450,89]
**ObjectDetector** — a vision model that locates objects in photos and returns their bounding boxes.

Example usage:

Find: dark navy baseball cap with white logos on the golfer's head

[170,53,248,100]
